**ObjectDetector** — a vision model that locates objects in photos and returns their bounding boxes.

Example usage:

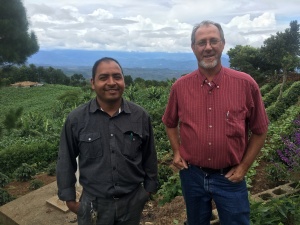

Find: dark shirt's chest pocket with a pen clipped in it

[122,130,142,159]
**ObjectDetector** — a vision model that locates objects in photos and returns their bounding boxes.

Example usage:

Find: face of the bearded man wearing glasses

[191,25,225,69]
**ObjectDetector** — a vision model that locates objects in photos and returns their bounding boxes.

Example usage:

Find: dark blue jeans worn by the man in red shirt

[180,165,250,225]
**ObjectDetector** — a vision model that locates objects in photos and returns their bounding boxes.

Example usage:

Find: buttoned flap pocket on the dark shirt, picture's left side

[79,133,103,158]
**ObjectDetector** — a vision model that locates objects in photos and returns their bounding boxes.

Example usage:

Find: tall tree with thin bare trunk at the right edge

[261,20,300,100]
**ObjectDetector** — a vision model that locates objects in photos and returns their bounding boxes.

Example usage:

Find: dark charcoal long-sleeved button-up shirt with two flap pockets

[57,99,158,201]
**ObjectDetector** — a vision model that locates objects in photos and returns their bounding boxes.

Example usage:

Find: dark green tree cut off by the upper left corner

[0,0,39,66]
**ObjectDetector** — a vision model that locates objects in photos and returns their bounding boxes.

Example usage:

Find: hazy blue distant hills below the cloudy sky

[28,50,229,80]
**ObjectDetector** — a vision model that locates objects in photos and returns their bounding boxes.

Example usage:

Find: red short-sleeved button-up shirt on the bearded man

[162,67,269,169]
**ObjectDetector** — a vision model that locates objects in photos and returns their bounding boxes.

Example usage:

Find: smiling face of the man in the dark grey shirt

[91,61,125,105]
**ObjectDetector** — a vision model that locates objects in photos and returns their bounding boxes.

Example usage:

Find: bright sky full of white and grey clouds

[23,0,300,52]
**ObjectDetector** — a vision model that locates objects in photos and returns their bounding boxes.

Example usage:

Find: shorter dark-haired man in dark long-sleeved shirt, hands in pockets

[57,57,158,225]
